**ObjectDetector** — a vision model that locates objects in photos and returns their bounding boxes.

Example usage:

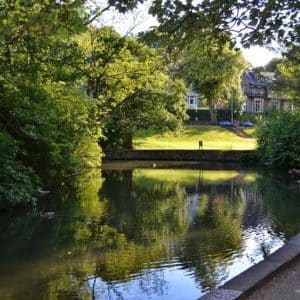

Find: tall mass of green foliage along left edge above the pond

[0,1,99,206]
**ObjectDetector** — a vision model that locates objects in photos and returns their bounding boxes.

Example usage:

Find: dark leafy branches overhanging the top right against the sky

[150,0,299,47]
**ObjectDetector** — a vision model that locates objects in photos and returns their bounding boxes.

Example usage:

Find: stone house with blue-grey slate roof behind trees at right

[242,70,287,113]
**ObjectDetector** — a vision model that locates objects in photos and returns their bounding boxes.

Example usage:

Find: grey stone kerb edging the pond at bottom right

[199,233,300,300]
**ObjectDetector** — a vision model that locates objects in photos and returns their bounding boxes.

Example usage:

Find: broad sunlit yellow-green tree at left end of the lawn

[80,27,186,148]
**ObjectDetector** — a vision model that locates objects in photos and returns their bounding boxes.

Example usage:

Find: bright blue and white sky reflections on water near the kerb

[88,224,284,300]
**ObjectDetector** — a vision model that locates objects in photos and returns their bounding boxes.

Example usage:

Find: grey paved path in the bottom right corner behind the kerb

[246,259,300,300]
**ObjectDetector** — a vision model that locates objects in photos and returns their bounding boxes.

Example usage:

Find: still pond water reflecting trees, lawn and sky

[0,168,300,299]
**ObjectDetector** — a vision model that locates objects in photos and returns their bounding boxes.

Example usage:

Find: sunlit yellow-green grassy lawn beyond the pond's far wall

[133,125,256,150]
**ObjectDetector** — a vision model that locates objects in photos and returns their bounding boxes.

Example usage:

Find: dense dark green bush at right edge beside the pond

[257,110,300,168]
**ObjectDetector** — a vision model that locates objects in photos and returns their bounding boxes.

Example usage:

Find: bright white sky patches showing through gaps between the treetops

[98,4,280,67]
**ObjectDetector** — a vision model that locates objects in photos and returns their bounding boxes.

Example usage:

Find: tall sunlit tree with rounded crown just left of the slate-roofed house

[180,38,247,123]
